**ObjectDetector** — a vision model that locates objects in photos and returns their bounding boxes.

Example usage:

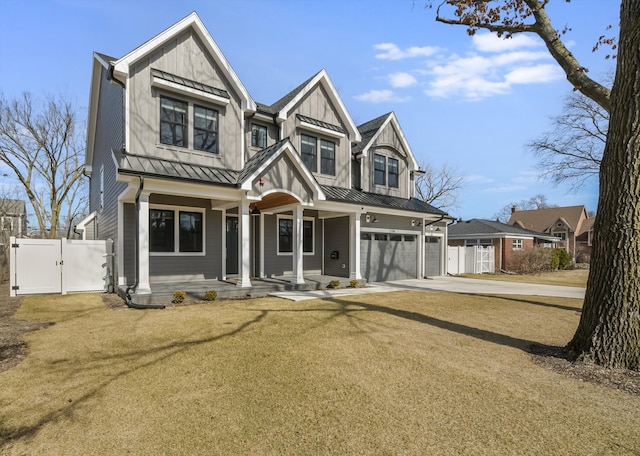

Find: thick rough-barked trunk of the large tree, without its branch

[568,0,640,369]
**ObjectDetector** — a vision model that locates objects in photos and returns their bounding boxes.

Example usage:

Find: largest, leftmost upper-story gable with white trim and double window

[105,12,256,170]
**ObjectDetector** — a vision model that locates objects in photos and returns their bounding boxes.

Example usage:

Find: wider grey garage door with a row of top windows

[360,233,419,282]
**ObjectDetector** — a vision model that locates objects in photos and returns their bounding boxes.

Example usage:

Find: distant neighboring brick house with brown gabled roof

[507,206,593,262]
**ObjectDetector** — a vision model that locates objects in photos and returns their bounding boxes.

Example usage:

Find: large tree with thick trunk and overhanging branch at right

[430,0,640,370]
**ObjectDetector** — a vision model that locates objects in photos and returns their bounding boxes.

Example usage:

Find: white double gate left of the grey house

[10,237,113,296]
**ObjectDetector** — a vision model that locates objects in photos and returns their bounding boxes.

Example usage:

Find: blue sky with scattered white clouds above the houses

[0,0,619,219]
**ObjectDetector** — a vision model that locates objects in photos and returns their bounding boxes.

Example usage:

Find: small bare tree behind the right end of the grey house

[416,163,462,211]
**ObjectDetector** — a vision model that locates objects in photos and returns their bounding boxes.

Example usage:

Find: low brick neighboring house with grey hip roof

[448,219,557,271]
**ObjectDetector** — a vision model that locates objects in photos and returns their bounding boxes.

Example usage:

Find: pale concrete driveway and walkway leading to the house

[270,277,585,301]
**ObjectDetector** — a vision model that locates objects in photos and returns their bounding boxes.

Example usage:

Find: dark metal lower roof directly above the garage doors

[321,185,448,216]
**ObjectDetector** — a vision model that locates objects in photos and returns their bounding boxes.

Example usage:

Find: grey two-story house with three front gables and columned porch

[86,13,450,300]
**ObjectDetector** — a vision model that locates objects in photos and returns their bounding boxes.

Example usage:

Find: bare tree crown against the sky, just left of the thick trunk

[527,92,609,190]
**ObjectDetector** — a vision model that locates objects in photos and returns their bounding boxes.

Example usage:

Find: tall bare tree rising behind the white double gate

[0,93,86,238]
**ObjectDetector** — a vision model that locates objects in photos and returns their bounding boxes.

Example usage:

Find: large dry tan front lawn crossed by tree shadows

[0,292,640,455]
